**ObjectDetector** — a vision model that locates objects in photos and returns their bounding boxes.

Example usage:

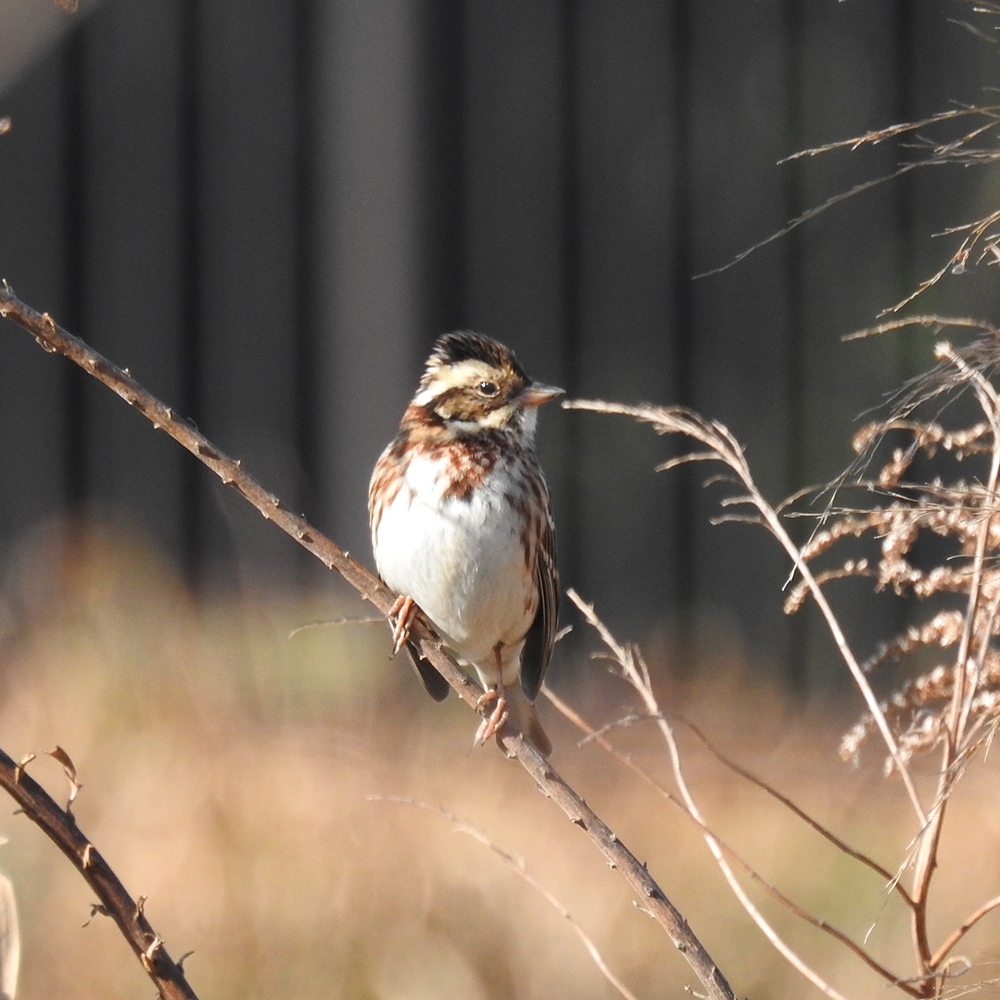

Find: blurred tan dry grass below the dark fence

[0,528,1000,1000]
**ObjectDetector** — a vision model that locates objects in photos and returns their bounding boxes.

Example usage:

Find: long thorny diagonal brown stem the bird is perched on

[0,282,734,1000]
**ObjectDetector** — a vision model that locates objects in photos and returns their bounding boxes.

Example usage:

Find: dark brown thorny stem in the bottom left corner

[0,750,198,1000]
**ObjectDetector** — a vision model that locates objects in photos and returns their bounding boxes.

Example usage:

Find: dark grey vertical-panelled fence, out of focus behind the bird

[0,0,996,680]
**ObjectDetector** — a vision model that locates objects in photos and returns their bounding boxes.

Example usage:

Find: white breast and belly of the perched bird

[375,458,536,683]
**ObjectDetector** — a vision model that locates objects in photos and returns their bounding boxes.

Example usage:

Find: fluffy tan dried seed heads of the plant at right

[785,336,1000,771]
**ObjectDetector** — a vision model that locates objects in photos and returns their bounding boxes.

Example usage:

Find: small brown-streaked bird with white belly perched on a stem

[368,330,563,757]
